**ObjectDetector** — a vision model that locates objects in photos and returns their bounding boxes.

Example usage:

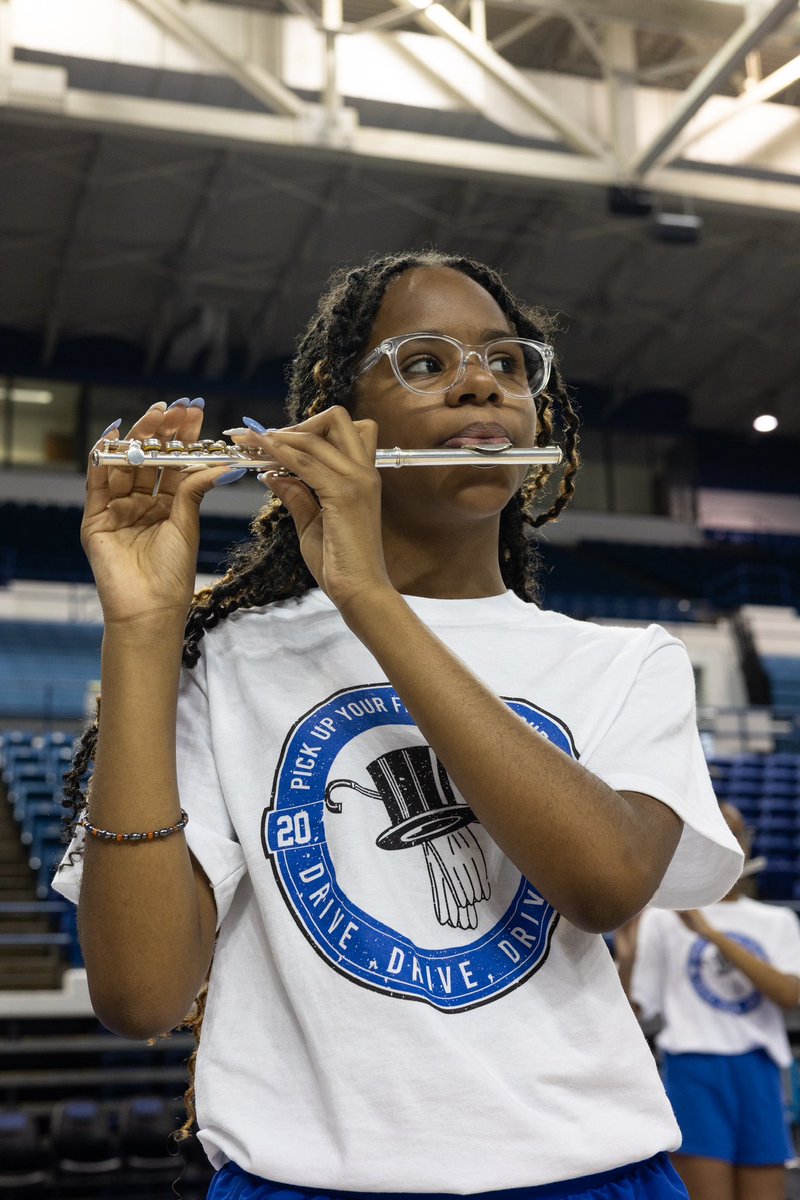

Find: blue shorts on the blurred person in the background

[662,1050,794,1166]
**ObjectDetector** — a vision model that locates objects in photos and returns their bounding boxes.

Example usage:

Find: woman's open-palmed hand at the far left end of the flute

[80,401,231,625]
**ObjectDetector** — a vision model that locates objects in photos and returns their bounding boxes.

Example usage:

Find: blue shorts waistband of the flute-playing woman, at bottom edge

[207,1154,688,1200]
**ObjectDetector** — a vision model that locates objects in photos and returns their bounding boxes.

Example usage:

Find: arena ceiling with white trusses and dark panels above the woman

[0,0,800,437]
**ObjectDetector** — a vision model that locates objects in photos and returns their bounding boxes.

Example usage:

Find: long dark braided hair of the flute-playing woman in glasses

[57,243,581,1136]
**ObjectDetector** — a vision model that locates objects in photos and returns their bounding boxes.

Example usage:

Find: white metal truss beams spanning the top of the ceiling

[0,0,800,212]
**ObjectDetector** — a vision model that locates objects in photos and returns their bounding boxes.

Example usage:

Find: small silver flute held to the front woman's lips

[91,438,563,470]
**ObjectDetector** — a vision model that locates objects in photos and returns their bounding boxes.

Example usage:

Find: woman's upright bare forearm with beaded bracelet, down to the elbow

[78,614,215,1037]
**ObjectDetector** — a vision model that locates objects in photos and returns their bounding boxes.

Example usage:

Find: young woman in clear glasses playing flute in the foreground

[55,252,741,1200]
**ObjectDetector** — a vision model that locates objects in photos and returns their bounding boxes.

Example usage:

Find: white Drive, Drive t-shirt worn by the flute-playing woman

[56,589,741,1193]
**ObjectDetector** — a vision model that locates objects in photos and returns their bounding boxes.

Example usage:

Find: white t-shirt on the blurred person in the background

[631,896,800,1067]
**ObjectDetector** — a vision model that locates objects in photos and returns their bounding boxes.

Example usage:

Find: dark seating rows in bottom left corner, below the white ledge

[0,1013,212,1200]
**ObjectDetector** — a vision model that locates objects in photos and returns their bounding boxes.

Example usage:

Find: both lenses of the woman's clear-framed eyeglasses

[396,336,546,396]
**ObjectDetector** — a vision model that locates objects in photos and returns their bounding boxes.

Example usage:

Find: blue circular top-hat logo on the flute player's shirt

[261,684,577,1012]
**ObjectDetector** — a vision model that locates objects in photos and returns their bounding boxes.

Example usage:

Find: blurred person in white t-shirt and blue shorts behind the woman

[615,804,800,1200]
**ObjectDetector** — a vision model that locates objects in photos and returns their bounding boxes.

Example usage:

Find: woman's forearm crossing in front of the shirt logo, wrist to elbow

[342,588,681,931]
